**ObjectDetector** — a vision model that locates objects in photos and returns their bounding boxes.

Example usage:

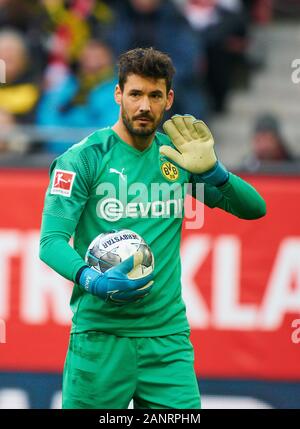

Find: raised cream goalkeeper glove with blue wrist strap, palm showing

[160,115,229,186]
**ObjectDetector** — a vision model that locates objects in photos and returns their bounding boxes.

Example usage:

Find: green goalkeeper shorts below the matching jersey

[63,331,201,409]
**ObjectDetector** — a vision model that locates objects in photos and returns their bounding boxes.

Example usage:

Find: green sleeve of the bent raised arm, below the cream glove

[191,173,266,220]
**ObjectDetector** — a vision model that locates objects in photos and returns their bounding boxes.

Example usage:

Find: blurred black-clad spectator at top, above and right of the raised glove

[183,0,247,113]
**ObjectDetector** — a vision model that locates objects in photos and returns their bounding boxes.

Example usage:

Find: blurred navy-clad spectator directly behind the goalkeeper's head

[107,0,206,118]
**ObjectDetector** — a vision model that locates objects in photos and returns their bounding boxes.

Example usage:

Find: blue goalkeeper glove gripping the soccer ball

[79,251,153,304]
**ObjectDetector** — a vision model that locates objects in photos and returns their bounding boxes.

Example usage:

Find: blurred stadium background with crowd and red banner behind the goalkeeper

[0,0,300,408]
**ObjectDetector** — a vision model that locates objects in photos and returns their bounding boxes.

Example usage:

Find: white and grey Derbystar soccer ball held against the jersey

[85,229,154,279]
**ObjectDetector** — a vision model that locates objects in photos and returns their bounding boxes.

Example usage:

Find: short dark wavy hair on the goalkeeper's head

[118,48,175,92]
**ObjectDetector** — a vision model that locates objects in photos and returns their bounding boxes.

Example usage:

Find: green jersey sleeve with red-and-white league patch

[40,147,93,281]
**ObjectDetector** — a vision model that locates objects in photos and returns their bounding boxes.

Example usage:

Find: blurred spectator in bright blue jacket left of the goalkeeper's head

[37,40,119,153]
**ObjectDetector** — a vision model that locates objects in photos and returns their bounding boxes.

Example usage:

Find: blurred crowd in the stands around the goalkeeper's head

[0,0,288,166]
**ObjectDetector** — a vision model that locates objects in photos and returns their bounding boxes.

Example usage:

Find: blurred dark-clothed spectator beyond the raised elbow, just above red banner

[244,113,294,171]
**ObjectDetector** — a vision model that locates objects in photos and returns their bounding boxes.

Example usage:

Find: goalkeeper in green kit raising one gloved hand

[40,48,266,409]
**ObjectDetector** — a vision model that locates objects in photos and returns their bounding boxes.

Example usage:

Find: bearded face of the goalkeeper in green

[115,74,174,137]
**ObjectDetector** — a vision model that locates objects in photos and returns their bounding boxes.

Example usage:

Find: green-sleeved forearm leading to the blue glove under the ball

[40,215,86,281]
